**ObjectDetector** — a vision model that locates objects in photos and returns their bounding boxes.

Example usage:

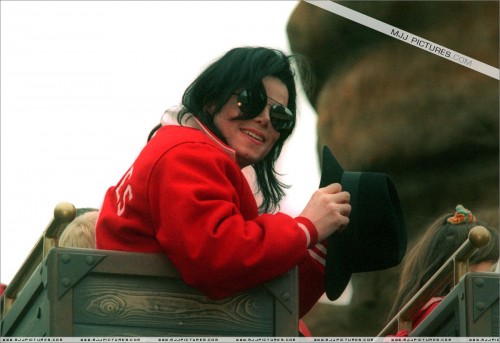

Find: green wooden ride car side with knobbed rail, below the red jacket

[0,203,299,337]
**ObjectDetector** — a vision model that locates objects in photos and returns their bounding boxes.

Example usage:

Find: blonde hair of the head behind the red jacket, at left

[59,211,99,249]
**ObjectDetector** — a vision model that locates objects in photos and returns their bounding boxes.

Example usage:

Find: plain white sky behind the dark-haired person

[0,1,319,284]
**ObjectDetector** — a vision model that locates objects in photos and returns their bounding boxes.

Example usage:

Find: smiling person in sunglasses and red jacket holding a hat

[96,47,351,322]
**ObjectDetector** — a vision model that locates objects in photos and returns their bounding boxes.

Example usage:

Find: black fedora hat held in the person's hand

[320,146,407,300]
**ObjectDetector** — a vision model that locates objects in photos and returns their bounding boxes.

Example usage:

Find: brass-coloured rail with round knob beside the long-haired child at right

[377,226,490,337]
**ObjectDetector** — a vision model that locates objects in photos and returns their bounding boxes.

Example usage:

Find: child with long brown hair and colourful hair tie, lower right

[389,205,499,337]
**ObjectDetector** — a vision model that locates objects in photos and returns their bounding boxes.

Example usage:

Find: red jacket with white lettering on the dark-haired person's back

[96,121,326,315]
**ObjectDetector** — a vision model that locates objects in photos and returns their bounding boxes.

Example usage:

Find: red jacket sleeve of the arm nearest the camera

[148,143,316,298]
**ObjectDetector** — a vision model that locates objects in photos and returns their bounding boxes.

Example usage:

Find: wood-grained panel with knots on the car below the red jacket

[73,274,275,336]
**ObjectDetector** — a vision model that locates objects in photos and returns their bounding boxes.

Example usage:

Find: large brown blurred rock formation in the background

[287,1,499,336]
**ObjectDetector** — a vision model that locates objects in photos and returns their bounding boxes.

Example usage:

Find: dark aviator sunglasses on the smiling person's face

[236,86,295,132]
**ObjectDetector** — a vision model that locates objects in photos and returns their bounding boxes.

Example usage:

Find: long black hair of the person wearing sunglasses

[177,47,297,213]
